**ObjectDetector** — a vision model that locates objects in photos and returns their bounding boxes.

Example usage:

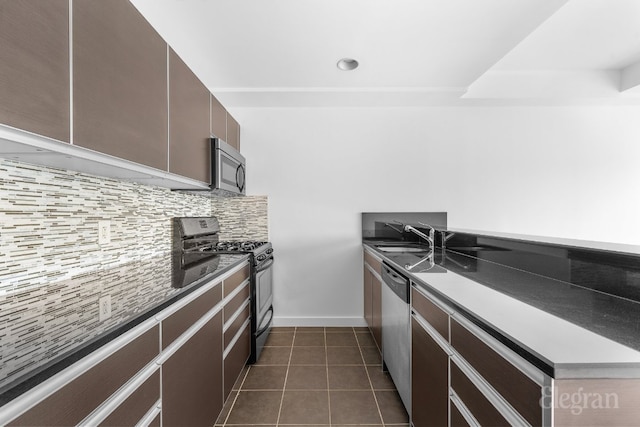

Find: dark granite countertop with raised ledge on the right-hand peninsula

[364,232,640,378]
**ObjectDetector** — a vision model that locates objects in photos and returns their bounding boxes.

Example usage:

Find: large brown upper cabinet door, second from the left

[72,0,168,171]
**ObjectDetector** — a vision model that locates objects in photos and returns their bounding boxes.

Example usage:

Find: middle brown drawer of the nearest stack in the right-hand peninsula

[451,363,509,426]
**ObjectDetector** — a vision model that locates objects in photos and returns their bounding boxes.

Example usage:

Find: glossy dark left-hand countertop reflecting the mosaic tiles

[0,253,248,406]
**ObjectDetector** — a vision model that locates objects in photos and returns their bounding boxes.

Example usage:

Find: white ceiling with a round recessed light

[131,0,640,109]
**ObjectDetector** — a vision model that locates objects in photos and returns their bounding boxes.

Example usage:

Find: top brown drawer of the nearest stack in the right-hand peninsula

[451,319,542,425]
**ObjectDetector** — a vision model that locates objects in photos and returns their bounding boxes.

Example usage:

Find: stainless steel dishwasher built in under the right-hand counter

[382,263,411,415]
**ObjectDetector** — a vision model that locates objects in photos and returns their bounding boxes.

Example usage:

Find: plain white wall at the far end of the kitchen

[233,107,640,325]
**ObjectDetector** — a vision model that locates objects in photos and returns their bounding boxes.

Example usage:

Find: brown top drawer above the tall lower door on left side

[162,285,222,349]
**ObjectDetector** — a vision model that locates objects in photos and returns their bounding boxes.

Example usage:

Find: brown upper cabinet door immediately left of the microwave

[169,49,211,183]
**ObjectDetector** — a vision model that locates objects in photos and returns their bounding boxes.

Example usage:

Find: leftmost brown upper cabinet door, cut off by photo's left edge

[0,0,70,142]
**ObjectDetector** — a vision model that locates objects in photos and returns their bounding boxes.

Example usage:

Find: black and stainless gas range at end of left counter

[173,217,274,363]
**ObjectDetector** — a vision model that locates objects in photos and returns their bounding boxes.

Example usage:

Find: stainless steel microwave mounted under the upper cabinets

[210,138,246,195]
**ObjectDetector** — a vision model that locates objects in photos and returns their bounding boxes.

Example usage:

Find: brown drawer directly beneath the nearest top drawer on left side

[100,371,160,426]
